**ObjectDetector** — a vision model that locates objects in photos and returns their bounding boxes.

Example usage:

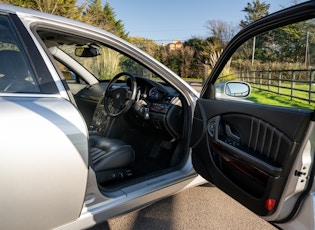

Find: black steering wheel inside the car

[104,72,137,117]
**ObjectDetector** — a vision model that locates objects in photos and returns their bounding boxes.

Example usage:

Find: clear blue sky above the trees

[79,0,303,44]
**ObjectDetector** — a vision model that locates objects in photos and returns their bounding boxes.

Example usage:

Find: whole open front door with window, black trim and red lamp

[191,2,315,226]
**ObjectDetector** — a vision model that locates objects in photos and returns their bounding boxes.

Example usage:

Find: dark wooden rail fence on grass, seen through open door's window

[237,69,315,104]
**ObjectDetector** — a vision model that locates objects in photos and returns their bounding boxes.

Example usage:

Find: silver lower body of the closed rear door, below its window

[0,95,88,229]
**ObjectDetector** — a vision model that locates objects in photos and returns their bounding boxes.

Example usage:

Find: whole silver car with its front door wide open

[0,1,315,230]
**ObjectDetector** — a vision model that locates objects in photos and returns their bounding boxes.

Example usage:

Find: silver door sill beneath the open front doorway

[57,155,205,230]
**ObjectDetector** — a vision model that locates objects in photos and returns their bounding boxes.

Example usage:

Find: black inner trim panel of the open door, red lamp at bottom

[192,99,313,216]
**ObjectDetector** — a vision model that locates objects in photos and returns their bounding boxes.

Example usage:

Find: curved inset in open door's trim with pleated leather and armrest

[208,114,295,198]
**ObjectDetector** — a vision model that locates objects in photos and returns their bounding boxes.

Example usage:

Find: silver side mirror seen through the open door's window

[215,81,251,98]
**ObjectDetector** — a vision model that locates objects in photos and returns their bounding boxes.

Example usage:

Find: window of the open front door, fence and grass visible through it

[215,19,315,109]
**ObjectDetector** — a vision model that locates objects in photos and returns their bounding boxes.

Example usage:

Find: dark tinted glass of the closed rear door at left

[0,15,40,93]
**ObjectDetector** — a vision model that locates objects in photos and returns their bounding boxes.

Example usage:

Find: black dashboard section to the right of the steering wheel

[133,78,183,139]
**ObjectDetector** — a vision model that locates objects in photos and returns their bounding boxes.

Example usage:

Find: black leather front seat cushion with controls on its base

[89,133,135,183]
